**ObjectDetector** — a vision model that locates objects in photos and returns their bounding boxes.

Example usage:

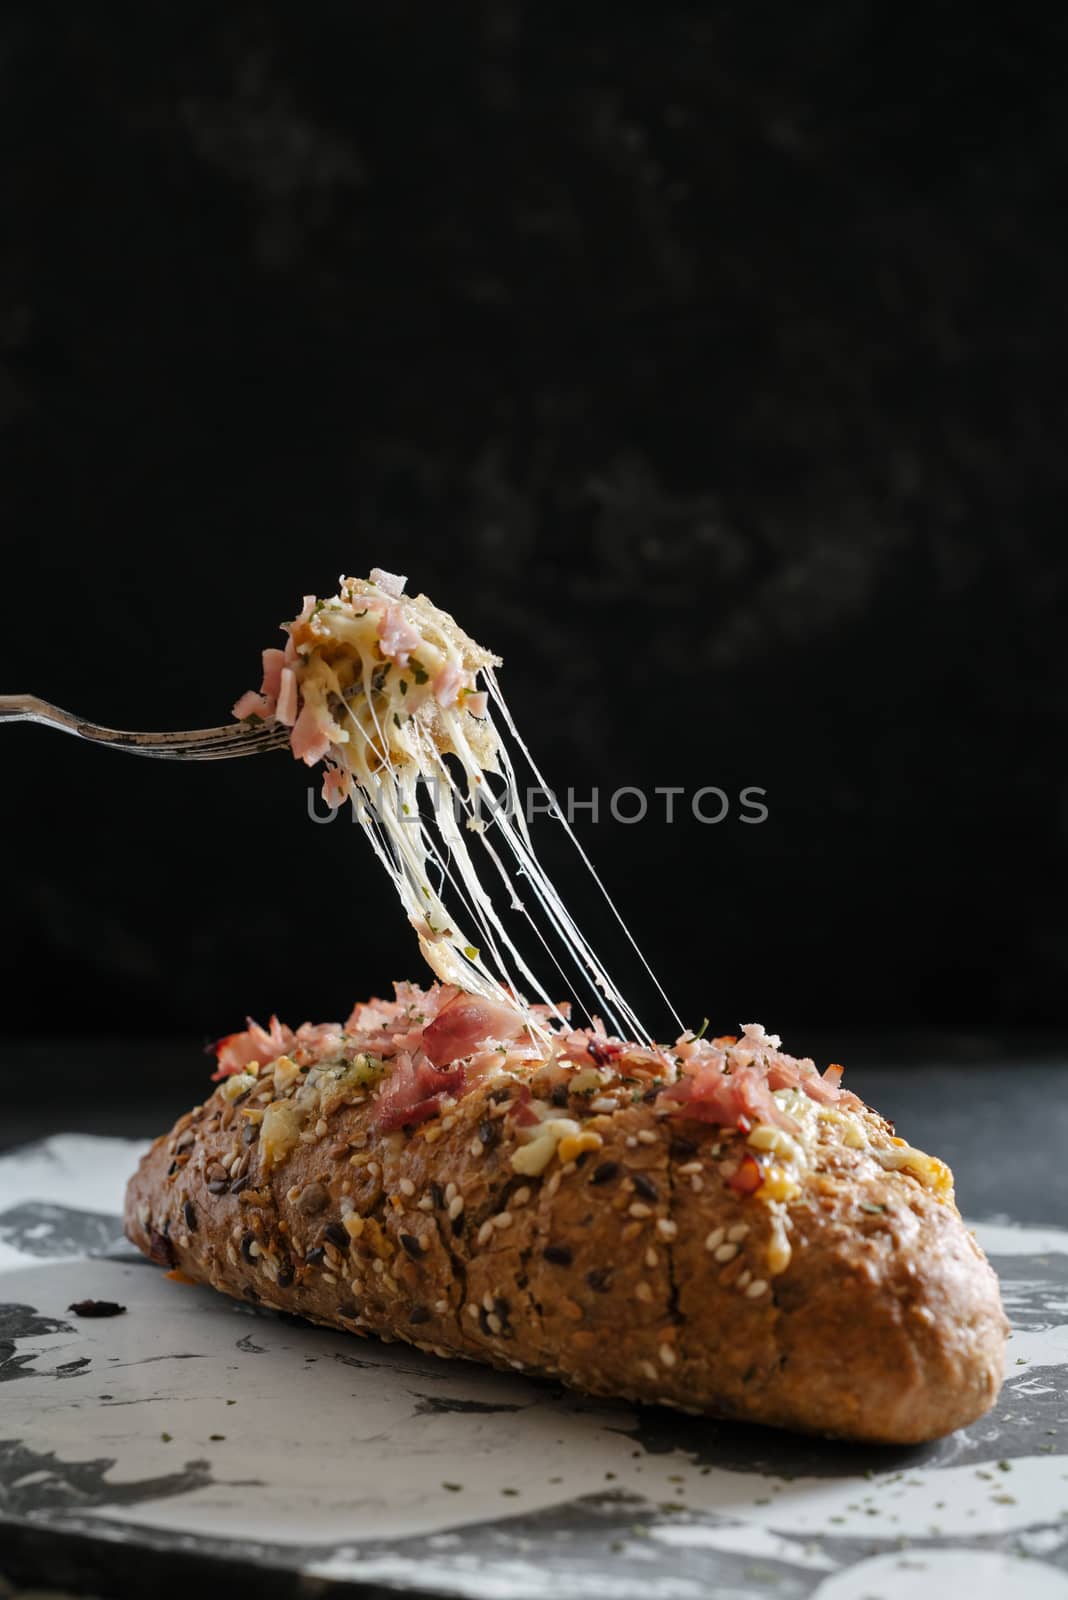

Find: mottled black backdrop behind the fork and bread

[0,9,1068,1050]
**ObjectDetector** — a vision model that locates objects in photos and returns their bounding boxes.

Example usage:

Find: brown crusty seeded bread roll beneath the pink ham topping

[126,1056,1007,1443]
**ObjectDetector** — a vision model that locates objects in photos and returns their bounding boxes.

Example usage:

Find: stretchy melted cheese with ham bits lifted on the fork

[254,571,683,1043]
